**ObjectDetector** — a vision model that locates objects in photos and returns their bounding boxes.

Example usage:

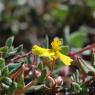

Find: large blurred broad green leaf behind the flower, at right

[68,32,85,48]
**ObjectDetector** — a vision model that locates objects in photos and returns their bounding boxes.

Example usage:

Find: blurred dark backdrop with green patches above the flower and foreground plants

[0,0,95,51]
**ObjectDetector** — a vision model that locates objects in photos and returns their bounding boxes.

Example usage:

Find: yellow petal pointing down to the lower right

[57,52,73,65]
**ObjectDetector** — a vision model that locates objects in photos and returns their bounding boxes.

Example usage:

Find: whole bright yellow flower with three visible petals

[32,38,73,65]
